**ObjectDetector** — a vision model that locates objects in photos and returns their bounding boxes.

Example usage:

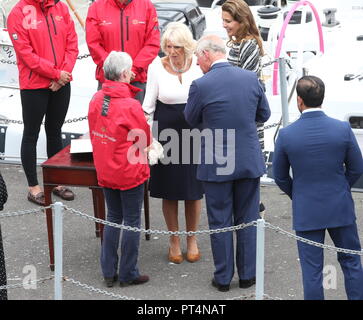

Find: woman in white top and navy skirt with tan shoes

[143,22,203,263]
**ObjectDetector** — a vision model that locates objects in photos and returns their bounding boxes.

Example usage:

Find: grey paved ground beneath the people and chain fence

[0,164,363,303]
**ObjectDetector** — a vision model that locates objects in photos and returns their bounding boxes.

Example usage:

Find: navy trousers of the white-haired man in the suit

[203,178,260,285]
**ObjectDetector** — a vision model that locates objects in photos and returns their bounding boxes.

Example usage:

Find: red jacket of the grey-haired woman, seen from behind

[88,80,152,190]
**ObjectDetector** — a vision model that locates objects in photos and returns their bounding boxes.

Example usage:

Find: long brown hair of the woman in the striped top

[222,0,264,55]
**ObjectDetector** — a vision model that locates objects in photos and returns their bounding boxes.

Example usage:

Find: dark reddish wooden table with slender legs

[41,146,150,271]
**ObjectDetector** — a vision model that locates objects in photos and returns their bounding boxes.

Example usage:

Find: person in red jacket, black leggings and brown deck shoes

[8,0,78,205]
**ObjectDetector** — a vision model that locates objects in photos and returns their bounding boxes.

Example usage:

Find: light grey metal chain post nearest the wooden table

[54,202,63,300]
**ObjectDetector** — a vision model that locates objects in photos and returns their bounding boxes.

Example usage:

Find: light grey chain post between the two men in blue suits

[256,219,265,300]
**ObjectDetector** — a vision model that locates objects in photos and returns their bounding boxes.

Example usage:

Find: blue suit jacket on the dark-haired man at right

[273,111,363,231]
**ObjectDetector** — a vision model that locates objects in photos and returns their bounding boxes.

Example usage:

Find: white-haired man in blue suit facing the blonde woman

[184,35,270,291]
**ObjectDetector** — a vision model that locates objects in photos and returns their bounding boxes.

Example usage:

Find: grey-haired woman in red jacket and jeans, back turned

[88,51,151,287]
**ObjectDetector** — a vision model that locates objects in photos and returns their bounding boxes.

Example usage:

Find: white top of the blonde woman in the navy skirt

[142,56,203,114]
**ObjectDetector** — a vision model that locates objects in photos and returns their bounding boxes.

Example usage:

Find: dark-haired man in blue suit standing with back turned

[273,76,363,300]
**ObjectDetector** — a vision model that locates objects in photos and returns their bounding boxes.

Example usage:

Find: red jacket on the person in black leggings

[7,0,78,89]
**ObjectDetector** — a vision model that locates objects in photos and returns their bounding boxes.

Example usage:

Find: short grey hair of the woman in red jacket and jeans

[103,51,132,81]
